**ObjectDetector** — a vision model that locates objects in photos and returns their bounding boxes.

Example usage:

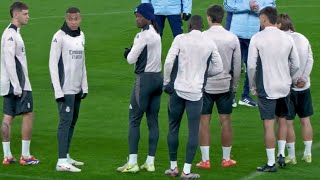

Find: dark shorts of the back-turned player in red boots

[202,92,233,114]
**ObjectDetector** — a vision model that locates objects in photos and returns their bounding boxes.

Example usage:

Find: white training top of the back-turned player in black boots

[247,26,299,99]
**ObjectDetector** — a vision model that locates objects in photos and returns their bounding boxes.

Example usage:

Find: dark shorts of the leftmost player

[3,91,33,117]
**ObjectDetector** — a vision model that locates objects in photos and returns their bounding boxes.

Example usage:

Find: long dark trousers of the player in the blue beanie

[129,73,163,156]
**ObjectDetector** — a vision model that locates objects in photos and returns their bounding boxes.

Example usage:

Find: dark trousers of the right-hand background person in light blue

[239,38,250,98]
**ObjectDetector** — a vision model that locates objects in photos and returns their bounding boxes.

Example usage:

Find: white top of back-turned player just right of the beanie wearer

[164,30,223,101]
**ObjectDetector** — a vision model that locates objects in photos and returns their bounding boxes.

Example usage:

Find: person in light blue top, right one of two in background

[223,0,276,107]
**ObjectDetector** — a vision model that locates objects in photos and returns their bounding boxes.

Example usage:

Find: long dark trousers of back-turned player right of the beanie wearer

[167,91,203,164]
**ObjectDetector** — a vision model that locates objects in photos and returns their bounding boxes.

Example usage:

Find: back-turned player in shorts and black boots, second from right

[248,7,299,172]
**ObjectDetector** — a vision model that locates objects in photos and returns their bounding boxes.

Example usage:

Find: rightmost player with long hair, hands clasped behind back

[277,14,313,164]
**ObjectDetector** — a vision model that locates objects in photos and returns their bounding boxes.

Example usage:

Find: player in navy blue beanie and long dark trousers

[117,3,163,173]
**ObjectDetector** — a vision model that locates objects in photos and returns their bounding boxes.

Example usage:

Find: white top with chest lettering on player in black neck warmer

[49,27,88,99]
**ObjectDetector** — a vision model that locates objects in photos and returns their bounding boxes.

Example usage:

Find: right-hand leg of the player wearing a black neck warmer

[67,93,84,166]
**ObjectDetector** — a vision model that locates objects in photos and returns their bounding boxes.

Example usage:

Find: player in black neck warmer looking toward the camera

[49,7,88,172]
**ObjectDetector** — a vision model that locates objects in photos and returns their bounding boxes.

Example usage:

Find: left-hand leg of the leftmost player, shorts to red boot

[1,94,16,165]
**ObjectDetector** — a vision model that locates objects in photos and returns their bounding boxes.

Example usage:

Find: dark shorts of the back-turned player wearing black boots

[258,95,290,120]
